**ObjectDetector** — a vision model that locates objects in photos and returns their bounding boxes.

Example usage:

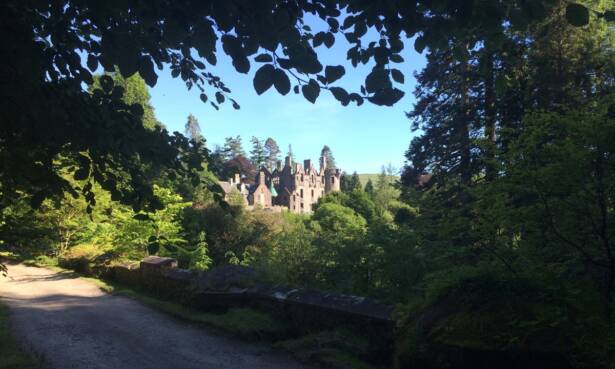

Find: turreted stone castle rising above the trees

[220,156,342,213]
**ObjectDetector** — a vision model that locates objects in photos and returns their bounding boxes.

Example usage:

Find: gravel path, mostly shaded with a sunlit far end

[0,265,316,369]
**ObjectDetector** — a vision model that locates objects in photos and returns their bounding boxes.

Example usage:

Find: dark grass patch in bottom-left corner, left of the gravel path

[0,304,43,369]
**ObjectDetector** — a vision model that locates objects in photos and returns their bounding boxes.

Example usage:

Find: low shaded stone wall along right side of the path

[102,256,394,357]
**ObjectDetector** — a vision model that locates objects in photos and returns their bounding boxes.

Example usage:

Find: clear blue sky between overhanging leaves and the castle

[150,22,425,173]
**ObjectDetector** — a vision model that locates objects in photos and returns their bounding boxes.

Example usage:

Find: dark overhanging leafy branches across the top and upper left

[0,0,614,209]
